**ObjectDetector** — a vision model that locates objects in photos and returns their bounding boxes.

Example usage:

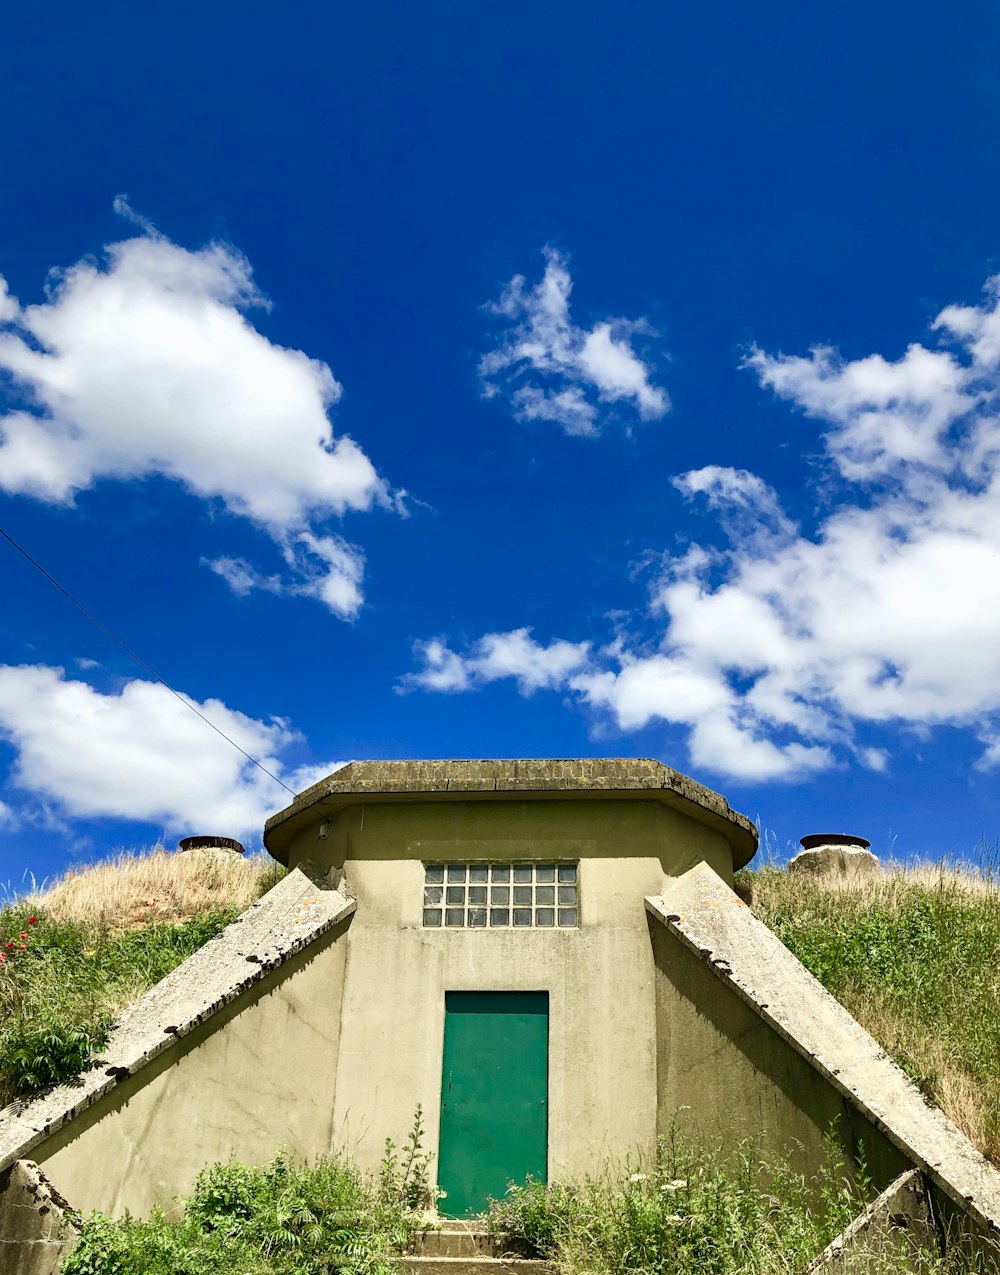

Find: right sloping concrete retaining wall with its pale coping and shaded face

[645,863,1000,1242]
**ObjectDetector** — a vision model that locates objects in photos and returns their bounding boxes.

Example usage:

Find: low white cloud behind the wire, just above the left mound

[0,664,341,835]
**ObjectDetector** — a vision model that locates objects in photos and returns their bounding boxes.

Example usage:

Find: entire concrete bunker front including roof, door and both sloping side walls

[0,759,1000,1275]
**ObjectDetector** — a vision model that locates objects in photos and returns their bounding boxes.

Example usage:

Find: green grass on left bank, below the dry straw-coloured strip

[0,905,236,1105]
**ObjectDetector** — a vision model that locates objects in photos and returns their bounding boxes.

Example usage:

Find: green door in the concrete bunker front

[438,992,548,1218]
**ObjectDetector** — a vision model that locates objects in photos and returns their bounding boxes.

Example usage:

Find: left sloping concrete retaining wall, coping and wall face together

[0,864,356,1214]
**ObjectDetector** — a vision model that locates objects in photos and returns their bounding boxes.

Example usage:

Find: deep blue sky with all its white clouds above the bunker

[0,3,1000,885]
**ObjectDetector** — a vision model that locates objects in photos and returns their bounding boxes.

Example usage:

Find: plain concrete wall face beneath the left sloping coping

[34,921,349,1216]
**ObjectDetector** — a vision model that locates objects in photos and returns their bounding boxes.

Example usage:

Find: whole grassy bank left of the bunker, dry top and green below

[0,848,276,1107]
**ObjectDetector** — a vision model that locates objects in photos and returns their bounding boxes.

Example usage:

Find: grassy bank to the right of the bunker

[740,866,1000,1163]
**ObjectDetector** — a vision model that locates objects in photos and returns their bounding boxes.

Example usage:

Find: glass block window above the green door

[423,863,579,929]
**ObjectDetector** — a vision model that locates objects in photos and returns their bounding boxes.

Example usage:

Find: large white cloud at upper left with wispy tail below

[0,204,392,617]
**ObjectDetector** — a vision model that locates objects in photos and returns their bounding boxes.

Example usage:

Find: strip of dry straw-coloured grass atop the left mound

[24,847,281,929]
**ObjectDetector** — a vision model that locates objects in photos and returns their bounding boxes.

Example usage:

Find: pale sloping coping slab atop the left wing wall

[0,863,357,1173]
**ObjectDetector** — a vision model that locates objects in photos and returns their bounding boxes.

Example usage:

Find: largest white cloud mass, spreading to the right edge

[412,271,1000,779]
